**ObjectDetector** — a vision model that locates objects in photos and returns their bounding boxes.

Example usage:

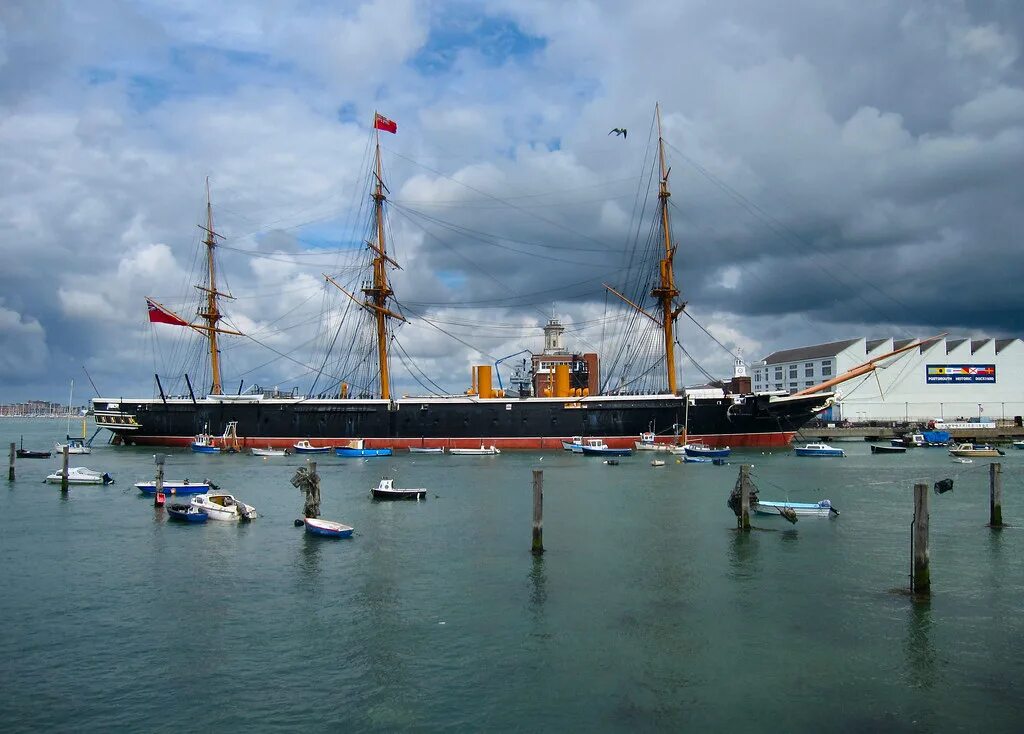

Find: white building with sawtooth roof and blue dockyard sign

[753,338,1024,422]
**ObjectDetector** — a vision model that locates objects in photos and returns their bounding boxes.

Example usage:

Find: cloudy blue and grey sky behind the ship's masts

[0,0,1024,402]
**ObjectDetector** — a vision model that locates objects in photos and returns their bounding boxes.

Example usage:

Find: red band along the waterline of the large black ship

[125,431,795,450]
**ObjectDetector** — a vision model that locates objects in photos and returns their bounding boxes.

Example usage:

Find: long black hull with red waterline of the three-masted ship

[92,395,829,449]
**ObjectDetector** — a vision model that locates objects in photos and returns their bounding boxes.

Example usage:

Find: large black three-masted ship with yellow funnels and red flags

[92,107,833,449]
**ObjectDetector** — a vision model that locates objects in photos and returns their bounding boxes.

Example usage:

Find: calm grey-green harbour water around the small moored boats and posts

[0,420,1024,732]
